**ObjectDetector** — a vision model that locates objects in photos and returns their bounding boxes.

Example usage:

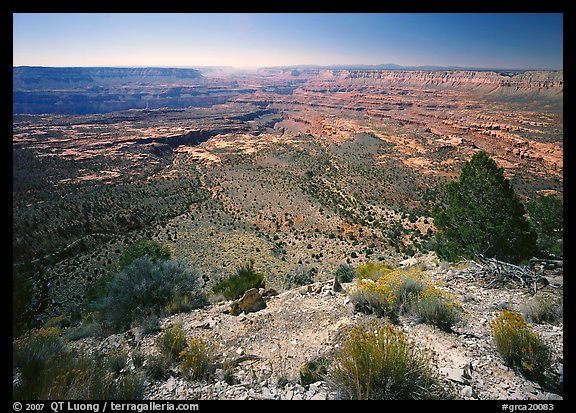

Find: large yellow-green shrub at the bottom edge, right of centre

[327,322,449,400]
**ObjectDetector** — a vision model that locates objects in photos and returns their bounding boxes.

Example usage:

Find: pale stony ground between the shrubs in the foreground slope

[67,254,563,400]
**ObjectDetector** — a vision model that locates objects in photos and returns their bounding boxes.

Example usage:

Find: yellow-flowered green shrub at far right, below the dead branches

[491,310,551,379]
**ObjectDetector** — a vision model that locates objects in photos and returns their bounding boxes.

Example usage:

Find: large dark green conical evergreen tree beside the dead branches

[433,151,536,262]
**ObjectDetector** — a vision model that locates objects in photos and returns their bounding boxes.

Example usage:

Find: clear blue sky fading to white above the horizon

[13,13,563,70]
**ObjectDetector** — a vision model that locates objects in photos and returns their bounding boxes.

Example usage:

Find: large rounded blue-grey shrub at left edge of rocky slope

[99,256,208,331]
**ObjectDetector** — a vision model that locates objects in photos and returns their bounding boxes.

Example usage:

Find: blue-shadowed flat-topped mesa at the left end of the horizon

[12,66,214,114]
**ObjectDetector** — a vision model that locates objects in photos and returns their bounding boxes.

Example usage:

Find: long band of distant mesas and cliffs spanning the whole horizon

[13,64,564,114]
